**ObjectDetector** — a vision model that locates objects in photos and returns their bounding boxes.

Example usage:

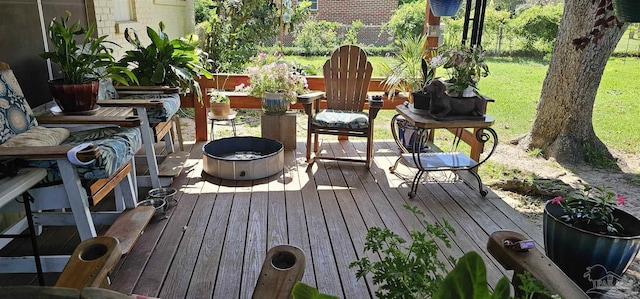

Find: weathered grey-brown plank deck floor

[0,141,543,298]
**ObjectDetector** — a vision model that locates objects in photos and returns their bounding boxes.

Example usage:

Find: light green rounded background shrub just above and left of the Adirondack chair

[293,19,340,54]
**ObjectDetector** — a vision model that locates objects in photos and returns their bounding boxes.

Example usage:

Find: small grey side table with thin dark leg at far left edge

[0,168,47,285]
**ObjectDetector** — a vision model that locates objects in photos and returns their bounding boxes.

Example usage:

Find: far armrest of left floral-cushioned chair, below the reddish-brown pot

[36,115,140,127]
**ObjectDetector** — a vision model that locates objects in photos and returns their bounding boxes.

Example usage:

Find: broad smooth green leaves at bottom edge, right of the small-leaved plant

[432,251,510,299]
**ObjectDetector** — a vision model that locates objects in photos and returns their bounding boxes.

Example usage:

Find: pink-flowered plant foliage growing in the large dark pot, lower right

[551,184,625,235]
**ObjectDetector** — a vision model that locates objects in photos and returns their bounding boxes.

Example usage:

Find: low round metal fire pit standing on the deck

[202,137,284,181]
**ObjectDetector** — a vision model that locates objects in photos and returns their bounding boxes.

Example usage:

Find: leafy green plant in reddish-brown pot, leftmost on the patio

[40,11,137,113]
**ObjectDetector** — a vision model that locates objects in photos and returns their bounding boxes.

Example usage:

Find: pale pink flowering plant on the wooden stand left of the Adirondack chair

[236,53,308,103]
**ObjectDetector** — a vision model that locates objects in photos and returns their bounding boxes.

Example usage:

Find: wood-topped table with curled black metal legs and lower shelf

[389,105,498,198]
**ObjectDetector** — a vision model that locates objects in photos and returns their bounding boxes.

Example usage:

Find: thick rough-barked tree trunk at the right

[519,0,626,163]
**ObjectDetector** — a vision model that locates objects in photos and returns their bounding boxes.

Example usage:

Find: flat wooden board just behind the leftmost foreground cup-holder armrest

[105,206,155,254]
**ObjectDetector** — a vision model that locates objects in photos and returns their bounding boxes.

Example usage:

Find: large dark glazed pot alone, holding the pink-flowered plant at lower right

[543,201,640,294]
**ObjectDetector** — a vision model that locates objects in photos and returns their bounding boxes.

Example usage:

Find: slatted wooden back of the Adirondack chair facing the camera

[323,45,373,111]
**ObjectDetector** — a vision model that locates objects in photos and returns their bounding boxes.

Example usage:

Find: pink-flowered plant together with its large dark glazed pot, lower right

[543,185,640,293]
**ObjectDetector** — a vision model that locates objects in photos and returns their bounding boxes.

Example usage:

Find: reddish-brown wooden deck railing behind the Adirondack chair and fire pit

[180,74,408,141]
